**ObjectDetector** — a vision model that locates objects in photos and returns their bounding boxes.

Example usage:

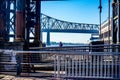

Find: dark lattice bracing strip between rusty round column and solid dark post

[25,0,36,42]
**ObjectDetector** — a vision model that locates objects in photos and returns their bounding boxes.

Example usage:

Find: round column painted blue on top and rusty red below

[15,0,25,42]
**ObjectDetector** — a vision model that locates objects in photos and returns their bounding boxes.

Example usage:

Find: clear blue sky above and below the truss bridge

[41,0,111,43]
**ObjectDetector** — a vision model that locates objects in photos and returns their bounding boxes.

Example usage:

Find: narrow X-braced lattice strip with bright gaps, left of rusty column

[6,0,16,40]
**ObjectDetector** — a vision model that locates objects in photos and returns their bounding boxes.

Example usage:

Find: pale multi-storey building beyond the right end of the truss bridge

[99,19,112,44]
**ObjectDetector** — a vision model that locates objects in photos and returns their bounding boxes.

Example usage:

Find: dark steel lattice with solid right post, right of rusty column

[25,0,41,47]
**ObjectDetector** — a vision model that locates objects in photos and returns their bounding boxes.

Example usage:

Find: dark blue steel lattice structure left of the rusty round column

[0,0,16,41]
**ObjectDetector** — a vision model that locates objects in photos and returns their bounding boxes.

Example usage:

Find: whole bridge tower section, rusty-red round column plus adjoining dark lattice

[15,0,42,46]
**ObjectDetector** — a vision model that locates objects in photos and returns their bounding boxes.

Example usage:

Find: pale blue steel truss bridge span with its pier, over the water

[41,13,99,45]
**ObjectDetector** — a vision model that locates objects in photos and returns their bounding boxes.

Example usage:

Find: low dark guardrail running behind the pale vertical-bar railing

[29,44,120,52]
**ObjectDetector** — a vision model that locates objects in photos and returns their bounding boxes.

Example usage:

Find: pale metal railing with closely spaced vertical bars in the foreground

[54,52,120,79]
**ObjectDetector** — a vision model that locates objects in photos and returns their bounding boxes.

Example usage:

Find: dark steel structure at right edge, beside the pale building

[112,0,120,44]
